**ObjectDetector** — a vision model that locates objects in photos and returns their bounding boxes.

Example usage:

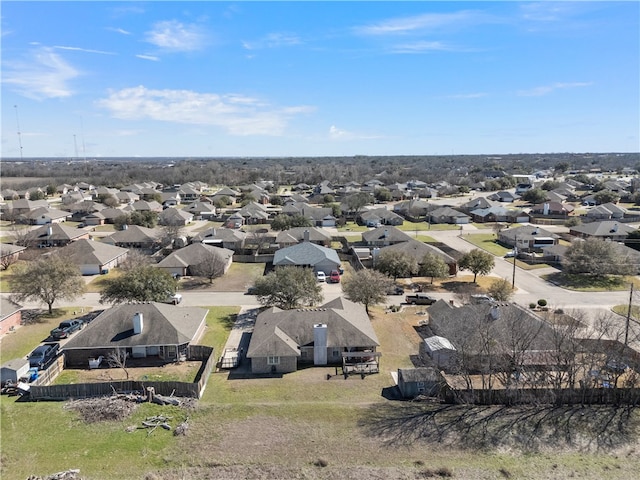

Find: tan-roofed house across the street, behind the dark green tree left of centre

[155,243,233,277]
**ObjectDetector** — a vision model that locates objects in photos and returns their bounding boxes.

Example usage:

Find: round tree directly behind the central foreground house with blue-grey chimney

[253,266,322,310]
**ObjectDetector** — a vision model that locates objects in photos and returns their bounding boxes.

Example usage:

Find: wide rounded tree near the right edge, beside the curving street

[562,238,634,277]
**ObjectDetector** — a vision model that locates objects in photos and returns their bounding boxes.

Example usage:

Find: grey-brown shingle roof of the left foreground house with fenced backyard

[64,303,208,350]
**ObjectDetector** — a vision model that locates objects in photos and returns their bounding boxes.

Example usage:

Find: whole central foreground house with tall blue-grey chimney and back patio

[247,297,380,374]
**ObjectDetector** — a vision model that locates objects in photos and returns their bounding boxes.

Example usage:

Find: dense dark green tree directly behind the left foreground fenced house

[100,264,177,303]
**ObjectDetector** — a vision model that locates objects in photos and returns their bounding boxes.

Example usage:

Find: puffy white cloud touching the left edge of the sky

[2,47,80,100]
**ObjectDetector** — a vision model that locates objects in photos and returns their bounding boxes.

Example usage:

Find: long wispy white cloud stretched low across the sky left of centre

[98,86,313,136]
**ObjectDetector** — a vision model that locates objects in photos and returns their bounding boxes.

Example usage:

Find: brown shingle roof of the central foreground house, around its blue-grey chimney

[247,297,379,358]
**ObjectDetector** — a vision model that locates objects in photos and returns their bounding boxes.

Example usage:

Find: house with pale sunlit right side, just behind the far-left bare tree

[60,239,129,275]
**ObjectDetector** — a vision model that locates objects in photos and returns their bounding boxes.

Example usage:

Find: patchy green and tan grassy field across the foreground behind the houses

[0,307,640,480]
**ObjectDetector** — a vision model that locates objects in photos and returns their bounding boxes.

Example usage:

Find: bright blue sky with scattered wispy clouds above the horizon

[1,1,640,158]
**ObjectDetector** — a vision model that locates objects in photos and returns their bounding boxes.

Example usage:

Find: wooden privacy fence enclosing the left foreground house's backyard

[29,345,215,401]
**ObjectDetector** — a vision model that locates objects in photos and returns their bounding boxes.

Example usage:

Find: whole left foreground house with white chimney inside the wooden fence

[64,303,208,368]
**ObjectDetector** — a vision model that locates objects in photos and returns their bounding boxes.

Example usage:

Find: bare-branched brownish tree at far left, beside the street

[11,254,84,313]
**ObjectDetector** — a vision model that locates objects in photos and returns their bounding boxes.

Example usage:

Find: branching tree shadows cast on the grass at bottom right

[359,402,639,452]
